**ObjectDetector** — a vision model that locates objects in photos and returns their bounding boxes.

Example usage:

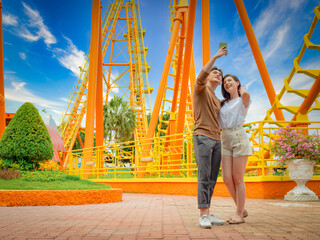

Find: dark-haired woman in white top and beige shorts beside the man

[218,74,252,224]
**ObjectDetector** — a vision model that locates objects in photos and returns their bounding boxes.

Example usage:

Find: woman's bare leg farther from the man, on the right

[232,156,248,218]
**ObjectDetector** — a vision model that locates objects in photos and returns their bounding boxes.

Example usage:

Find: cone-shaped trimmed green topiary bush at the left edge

[0,102,54,170]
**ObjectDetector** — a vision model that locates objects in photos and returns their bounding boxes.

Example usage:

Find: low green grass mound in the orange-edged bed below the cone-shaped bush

[0,171,111,190]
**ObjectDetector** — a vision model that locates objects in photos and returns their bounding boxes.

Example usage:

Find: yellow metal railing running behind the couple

[64,121,320,181]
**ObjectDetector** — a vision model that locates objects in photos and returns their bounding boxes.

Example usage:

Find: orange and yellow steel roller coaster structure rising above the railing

[55,0,320,172]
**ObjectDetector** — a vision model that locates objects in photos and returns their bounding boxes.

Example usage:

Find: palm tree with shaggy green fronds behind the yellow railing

[103,96,136,142]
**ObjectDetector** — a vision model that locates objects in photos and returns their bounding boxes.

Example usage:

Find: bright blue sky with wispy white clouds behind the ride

[2,0,320,124]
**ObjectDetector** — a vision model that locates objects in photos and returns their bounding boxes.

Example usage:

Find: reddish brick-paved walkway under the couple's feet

[0,193,320,240]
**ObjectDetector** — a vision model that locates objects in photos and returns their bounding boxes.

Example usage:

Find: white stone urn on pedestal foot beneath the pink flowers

[284,159,319,201]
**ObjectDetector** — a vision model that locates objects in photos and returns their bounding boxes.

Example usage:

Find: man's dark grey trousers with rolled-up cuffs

[193,135,221,208]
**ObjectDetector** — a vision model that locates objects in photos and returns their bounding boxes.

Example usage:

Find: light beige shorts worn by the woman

[221,126,252,157]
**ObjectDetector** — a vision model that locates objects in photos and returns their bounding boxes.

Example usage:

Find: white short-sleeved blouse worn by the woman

[218,97,251,129]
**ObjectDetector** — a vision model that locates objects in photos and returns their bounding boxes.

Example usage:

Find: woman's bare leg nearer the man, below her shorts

[221,155,237,206]
